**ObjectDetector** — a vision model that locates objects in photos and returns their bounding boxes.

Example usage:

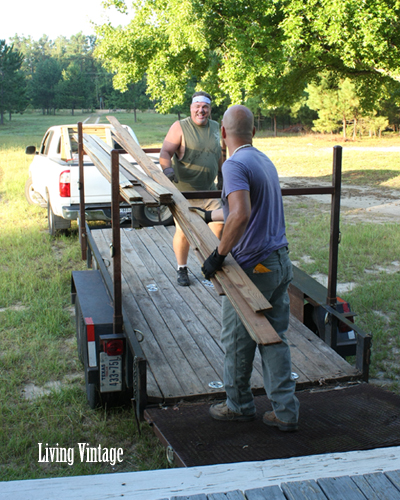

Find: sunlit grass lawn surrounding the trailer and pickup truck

[0,109,400,480]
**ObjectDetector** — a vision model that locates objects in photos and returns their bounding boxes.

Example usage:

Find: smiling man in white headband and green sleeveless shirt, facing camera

[160,92,223,286]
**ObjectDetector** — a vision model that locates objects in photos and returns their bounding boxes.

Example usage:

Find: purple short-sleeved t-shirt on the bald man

[222,147,288,269]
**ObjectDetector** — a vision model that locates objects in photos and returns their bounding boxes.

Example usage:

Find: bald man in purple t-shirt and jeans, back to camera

[202,106,299,431]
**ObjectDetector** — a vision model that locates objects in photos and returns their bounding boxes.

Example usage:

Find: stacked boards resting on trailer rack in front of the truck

[78,134,172,206]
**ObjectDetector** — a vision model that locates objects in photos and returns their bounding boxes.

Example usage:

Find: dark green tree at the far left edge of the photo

[0,40,27,125]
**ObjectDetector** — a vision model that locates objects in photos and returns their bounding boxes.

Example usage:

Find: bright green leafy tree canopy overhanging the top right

[95,0,400,111]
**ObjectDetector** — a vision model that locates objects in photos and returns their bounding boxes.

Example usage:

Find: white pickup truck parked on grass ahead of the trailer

[25,124,172,236]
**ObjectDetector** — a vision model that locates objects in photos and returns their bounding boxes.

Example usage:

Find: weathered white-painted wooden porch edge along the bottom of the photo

[0,447,400,500]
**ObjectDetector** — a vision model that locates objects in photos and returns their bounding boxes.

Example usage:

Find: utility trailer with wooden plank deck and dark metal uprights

[71,125,371,458]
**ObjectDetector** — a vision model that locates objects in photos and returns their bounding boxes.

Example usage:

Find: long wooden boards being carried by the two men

[107,116,281,345]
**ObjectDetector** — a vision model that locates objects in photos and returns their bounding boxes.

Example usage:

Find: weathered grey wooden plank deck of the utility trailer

[91,226,360,403]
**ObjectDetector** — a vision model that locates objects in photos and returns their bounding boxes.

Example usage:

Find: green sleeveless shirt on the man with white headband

[172,116,221,191]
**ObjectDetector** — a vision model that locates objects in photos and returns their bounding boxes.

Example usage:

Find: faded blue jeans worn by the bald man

[221,247,299,423]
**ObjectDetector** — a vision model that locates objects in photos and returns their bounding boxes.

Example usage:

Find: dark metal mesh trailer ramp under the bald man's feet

[145,383,400,467]
